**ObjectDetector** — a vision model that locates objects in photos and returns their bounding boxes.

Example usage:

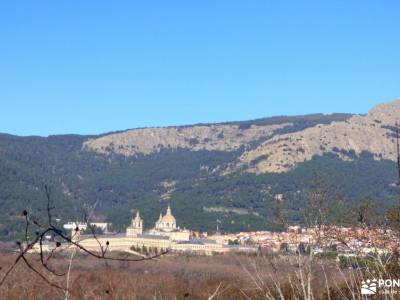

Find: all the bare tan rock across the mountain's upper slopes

[84,100,400,174]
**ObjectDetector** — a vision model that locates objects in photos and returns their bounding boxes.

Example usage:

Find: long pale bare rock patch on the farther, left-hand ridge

[84,123,291,156]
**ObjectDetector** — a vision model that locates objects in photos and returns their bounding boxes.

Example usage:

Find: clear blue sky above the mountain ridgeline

[0,0,400,135]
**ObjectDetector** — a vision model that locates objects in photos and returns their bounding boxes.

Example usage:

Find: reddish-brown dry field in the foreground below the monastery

[0,253,384,300]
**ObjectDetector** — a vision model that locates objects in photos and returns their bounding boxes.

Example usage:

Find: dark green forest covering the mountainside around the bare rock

[0,110,397,240]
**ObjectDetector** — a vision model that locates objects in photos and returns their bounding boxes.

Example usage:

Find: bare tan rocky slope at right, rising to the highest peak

[236,100,400,173]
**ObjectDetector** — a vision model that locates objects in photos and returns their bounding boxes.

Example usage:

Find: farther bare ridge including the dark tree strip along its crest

[83,113,353,156]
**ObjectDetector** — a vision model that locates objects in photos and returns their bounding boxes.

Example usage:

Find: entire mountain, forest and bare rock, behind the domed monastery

[0,100,400,239]
